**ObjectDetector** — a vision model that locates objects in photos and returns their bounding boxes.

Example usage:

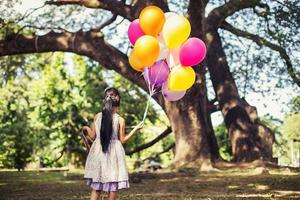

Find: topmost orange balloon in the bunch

[139,6,166,36]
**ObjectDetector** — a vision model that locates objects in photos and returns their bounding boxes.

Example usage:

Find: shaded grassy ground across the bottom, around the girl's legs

[0,169,300,200]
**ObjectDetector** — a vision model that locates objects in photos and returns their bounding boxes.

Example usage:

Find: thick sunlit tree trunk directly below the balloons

[159,64,219,170]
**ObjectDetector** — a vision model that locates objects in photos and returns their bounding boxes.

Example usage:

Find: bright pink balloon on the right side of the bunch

[179,38,206,66]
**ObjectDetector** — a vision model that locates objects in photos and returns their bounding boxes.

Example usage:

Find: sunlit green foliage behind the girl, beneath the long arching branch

[0,50,171,168]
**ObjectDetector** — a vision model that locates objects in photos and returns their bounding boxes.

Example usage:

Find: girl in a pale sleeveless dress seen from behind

[83,88,143,200]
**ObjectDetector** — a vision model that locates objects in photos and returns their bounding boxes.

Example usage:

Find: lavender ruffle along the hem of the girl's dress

[87,179,129,192]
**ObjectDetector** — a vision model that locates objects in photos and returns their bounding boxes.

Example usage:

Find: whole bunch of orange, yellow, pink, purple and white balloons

[128,6,206,101]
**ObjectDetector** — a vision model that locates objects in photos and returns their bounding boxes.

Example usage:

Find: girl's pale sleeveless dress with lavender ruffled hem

[84,113,129,192]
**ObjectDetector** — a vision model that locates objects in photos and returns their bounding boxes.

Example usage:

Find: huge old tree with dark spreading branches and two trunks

[0,0,300,168]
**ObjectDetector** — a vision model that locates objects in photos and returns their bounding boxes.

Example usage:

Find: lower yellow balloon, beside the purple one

[168,65,196,91]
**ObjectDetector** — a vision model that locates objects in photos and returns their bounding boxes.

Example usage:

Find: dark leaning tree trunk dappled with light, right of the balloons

[206,26,274,162]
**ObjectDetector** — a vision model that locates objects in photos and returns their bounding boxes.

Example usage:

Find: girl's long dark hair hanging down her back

[100,87,121,153]
